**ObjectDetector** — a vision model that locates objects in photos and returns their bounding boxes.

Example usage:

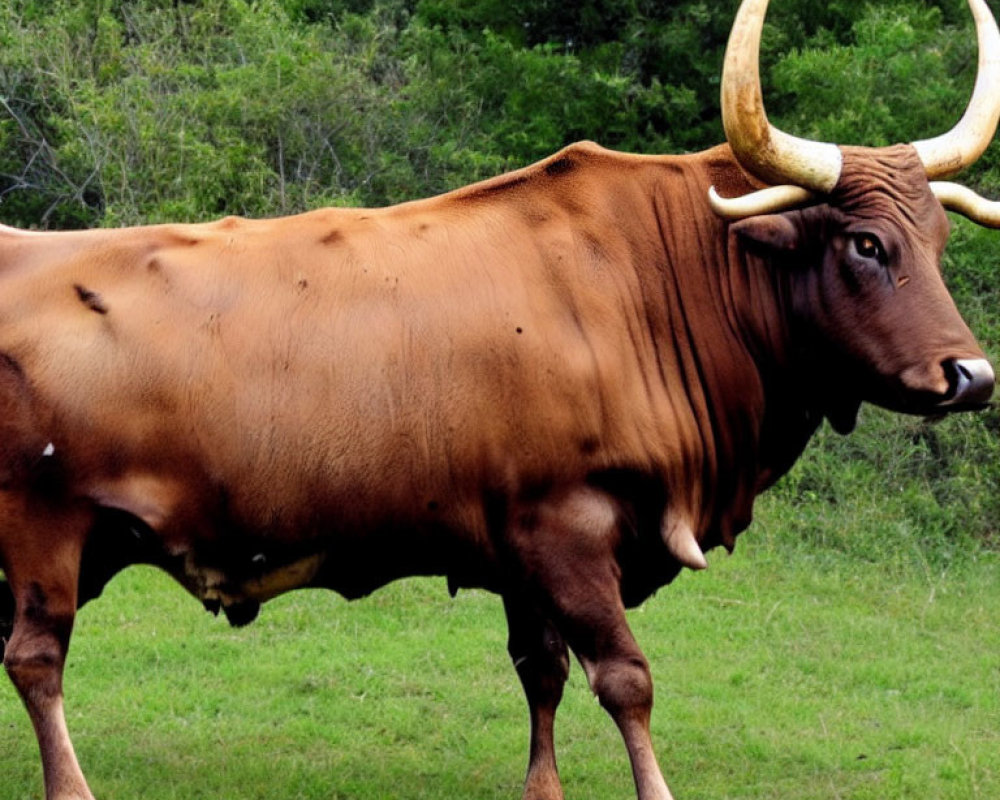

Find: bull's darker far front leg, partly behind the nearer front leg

[504,595,569,800]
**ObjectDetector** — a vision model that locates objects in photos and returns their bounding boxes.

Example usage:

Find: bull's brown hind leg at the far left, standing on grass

[0,498,93,800]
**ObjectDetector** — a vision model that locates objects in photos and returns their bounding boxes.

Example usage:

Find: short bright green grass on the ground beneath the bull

[0,502,1000,800]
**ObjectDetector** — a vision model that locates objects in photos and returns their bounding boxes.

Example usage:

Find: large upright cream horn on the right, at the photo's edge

[913,0,1000,179]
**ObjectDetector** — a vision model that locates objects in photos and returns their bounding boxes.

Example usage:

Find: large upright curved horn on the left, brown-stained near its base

[722,0,840,193]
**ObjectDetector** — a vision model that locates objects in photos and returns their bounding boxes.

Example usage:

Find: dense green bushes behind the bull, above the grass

[0,0,1000,558]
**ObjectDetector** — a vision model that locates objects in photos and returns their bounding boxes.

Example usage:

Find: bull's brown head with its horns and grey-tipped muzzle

[710,0,1000,427]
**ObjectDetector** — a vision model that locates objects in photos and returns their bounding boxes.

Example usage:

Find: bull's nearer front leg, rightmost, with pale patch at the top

[510,488,671,800]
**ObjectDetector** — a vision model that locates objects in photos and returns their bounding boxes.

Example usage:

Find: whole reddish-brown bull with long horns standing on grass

[0,0,1000,800]
